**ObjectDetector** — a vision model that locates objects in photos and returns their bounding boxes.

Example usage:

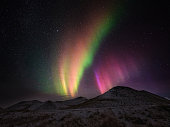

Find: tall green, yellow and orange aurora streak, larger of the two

[54,3,122,96]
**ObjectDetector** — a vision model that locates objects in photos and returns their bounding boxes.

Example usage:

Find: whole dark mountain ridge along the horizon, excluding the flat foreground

[5,86,170,111]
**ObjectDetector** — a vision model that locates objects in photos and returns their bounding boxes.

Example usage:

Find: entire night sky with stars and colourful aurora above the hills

[0,0,170,107]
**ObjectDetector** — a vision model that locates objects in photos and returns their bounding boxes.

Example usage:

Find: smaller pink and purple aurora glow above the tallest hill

[94,56,139,94]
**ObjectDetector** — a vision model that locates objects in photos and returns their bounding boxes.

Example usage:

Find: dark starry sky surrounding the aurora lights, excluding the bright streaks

[0,0,170,106]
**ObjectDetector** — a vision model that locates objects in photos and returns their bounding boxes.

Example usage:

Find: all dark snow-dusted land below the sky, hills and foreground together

[0,86,170,127]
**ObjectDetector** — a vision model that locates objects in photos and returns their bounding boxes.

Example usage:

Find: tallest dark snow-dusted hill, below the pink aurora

[69,86,170,108]
